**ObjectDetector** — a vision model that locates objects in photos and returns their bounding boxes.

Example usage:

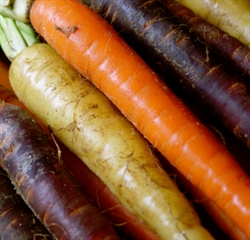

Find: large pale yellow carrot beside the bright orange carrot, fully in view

[9,44,212,239]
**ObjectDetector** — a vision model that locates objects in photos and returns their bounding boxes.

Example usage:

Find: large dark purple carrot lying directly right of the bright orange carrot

[81,0,250,148]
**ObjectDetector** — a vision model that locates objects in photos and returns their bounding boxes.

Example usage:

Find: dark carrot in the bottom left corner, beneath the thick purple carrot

[0,168,54,240]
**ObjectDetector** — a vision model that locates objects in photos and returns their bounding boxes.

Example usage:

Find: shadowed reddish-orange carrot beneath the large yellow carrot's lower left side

[0,85,159,240]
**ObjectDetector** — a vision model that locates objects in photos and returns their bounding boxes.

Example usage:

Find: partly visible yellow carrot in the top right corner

[177,0,250,47]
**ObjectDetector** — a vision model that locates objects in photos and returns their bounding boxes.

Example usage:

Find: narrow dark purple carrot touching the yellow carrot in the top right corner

[161,0,250,78]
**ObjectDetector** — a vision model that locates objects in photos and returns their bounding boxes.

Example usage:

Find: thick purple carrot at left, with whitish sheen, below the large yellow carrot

[0,103,120,240]
